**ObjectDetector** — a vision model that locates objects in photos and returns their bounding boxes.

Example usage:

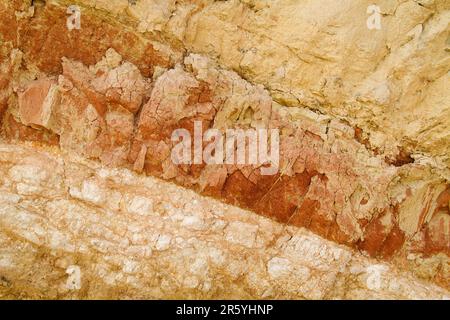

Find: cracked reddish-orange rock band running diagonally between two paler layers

[0,1,450,287]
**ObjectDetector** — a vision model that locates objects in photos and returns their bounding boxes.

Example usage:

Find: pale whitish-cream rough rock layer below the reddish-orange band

[0,144,449,299]
